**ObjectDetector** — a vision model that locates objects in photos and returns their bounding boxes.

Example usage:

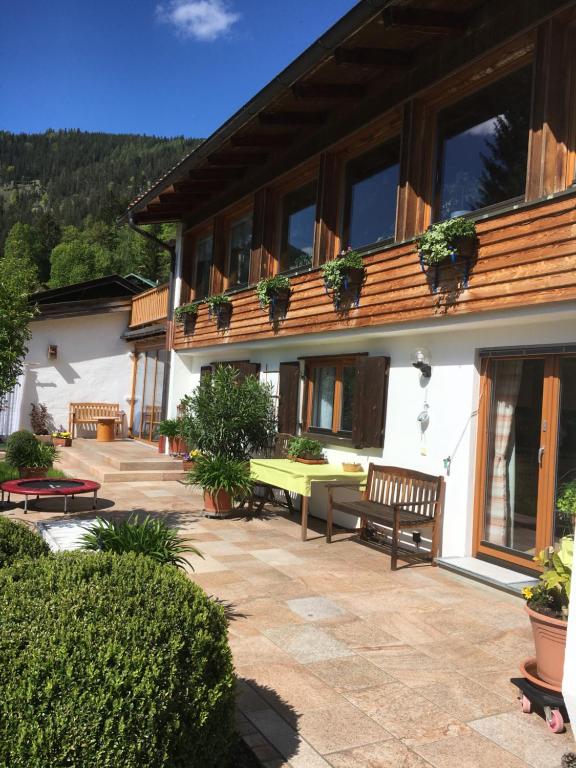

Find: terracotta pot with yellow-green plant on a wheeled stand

[522,536,574,690]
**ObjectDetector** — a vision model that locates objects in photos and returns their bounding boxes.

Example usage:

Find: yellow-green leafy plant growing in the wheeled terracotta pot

[522,536,574,620]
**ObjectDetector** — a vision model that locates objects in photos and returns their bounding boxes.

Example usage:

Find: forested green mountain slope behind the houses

[0,130,200,287]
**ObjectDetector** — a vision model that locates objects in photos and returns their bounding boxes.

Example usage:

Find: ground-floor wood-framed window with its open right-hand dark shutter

[302,355,390,448]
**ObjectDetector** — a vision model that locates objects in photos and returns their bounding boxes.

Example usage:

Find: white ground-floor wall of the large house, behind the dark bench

[172,305,576,557]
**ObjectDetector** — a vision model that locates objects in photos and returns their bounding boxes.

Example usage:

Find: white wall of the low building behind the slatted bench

[20,311,132,429]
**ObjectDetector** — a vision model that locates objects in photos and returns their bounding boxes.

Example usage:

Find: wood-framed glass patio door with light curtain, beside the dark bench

[475,354,576,568]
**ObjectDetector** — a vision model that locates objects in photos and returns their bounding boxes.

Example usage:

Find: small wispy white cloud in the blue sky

[156,0,240,42]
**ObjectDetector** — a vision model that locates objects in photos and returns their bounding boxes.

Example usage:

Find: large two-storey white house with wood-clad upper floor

[125,0,576,581]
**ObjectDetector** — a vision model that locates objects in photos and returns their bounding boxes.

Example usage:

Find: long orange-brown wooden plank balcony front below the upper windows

[174,195,576,349]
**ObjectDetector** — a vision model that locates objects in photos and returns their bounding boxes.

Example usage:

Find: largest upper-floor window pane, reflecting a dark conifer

[436,67,532,219]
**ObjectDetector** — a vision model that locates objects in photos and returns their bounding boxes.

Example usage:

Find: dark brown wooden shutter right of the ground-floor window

[352,357,390,448]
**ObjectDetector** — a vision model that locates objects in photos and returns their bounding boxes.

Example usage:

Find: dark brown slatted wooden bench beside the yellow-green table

[326,464,445,571]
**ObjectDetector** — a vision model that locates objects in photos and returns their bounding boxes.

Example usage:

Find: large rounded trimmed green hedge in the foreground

[0,552,234,768]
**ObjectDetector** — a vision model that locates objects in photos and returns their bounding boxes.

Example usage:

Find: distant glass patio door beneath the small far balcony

[131,349,167,443]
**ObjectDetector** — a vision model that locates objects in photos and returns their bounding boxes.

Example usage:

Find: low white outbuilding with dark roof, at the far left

[0,275,165,444]
